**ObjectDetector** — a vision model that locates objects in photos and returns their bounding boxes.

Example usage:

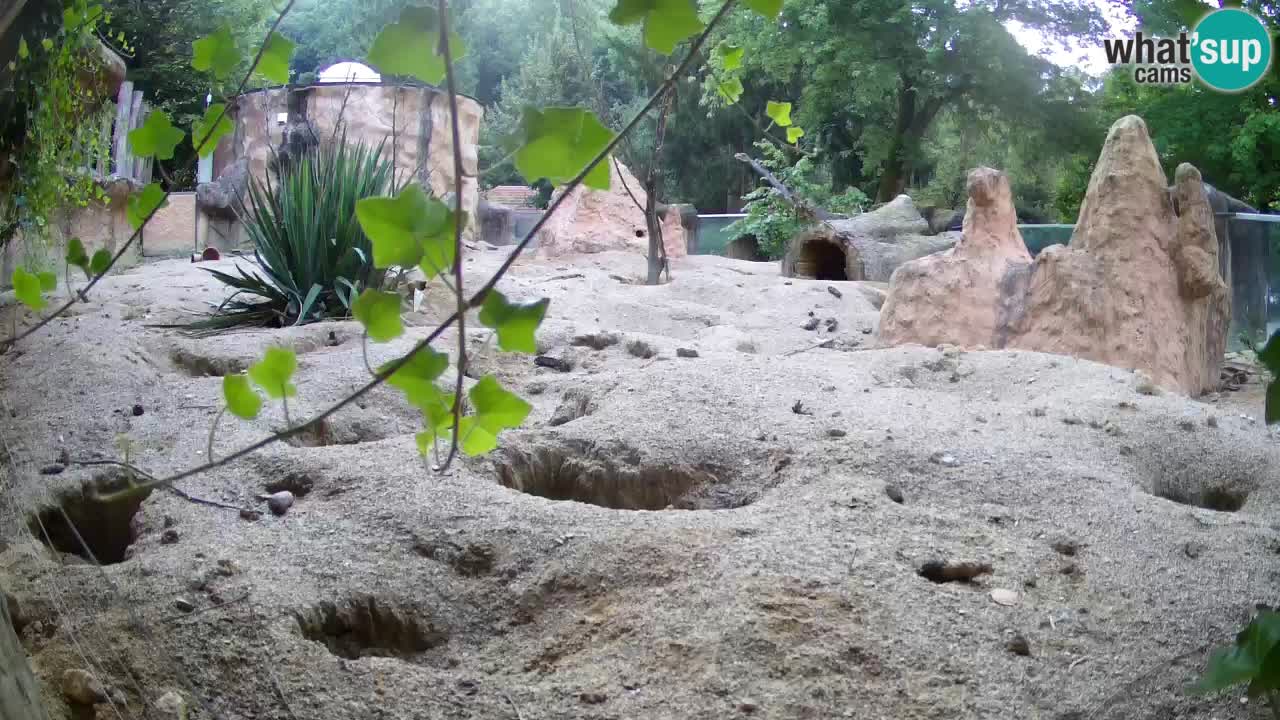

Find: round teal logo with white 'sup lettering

[1192,8,1275,92]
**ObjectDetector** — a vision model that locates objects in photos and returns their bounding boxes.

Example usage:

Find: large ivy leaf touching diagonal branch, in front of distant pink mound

[516,108,617,190]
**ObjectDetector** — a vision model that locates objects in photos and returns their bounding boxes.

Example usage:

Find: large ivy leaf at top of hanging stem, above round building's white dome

[369,6,467,85]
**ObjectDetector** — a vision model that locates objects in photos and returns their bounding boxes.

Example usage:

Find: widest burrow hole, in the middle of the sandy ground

[494,445,759,510]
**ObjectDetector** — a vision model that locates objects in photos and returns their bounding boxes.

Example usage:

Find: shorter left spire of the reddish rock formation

[879,168,1032,347]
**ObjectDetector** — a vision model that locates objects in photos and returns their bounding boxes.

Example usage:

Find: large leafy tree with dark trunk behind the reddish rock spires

[727,0,1103,201]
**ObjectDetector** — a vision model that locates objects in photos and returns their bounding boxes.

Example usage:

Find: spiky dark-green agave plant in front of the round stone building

[188,138,394,332]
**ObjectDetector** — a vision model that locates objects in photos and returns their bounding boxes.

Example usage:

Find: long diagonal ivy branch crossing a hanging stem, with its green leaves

[87,0,757,492]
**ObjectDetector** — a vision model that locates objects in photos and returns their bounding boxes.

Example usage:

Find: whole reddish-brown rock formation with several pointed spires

[879,115,1230,395]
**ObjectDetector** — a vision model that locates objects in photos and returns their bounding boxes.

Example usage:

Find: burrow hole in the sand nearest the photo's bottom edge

[294,596,449,660]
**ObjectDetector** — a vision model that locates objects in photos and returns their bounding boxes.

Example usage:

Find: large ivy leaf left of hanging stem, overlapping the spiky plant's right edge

[356,183,457,277]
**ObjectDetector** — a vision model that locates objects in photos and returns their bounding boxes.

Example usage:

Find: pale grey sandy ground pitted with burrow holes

[0,249,1280,720]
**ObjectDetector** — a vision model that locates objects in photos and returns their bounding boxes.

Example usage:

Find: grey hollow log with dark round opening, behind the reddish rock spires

[782,195,960,282]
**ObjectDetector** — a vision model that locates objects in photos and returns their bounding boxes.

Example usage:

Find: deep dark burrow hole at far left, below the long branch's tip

[27,477,151,565]
